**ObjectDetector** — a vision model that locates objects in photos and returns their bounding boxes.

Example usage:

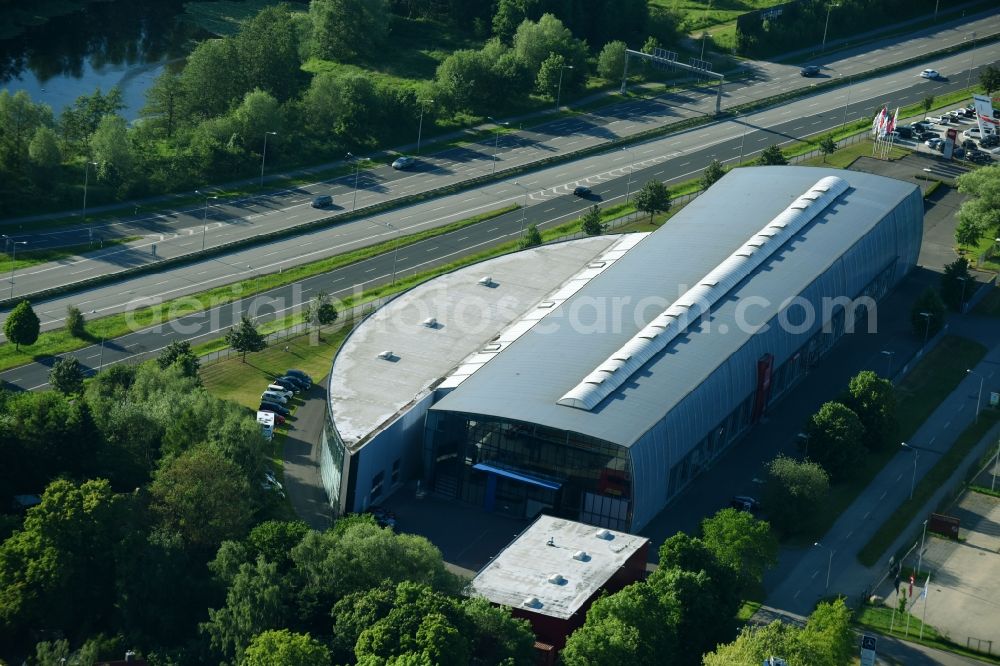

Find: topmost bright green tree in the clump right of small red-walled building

[701,508,778,593]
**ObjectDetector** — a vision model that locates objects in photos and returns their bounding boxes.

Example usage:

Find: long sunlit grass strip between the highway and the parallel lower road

[0,204,518,370]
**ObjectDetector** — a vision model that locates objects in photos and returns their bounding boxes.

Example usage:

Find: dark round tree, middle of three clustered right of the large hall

[806,402,865,481]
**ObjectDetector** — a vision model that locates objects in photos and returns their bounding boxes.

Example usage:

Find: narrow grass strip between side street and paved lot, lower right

[858,411,1000,567]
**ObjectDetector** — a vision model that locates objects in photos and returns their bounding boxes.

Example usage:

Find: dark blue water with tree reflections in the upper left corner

[0,0,208,120]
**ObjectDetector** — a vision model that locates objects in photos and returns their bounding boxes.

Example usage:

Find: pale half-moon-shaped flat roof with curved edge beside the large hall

[329,234,624,448]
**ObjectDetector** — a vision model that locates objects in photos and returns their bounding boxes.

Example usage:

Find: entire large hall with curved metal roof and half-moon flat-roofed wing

[323,167,923,531]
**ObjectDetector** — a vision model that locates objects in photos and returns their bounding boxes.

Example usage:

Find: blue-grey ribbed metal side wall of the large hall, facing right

[629,189,923,531]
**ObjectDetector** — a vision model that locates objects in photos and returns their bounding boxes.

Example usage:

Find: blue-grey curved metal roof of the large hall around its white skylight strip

[431,166,915,447]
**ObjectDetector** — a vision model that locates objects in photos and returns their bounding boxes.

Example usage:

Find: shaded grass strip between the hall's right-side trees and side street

[789,335,986,544]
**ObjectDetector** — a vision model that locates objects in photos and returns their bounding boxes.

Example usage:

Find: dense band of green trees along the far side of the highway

[0,0,684,215]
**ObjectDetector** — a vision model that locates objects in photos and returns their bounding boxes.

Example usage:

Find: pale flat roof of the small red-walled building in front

[468,515,649,619]
